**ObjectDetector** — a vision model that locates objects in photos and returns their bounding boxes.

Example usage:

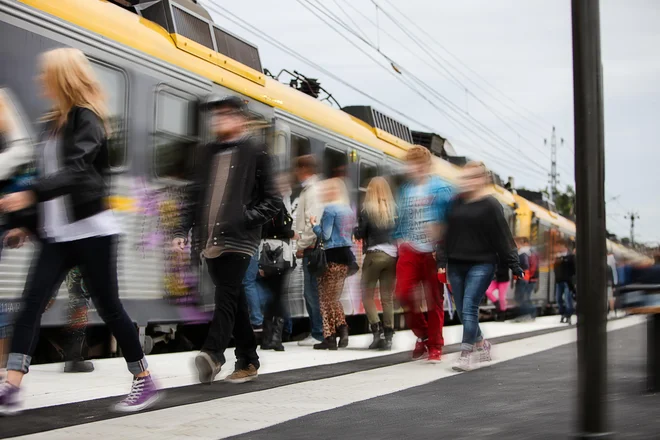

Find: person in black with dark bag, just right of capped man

[259,173,299,351]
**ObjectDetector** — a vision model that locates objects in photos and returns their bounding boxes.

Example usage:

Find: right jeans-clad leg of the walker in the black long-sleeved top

[461,264,495,351]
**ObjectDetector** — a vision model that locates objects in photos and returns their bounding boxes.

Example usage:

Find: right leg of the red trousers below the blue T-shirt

[420,254,445,352]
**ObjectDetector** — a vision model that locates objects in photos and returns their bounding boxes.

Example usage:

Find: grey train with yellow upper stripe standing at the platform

[0,0,645,354]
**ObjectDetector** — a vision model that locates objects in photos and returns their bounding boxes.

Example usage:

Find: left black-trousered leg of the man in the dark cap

[201,253,250,364]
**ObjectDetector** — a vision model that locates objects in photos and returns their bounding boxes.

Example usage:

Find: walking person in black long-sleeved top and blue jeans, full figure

[446,162,523,371]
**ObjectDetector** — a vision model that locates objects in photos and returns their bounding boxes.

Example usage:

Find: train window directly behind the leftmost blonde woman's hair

[92,62,128,168]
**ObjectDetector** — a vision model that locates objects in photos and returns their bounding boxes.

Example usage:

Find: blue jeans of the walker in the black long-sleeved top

[447,263,495,351]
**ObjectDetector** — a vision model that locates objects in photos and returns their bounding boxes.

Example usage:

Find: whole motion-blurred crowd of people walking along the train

[0,49,644,413]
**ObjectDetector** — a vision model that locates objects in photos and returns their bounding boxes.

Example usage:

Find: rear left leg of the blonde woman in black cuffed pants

[7,243,72,387]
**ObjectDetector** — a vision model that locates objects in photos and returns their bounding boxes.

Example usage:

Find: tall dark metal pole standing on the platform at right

[572,0,611,439]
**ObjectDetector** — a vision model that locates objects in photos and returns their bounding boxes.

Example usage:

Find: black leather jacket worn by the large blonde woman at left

[11,107,110,234]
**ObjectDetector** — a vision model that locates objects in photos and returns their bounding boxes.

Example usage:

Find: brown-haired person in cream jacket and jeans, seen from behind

[295,155,323,347]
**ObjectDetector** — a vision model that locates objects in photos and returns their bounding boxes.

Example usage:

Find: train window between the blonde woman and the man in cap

[154,90,198,180]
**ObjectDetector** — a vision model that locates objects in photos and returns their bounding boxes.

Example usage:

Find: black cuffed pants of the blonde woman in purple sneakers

[11,236,146,374]
